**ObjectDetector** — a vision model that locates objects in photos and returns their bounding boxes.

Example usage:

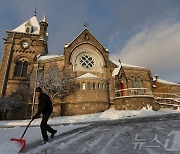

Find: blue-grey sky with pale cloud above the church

[0,0,180,82]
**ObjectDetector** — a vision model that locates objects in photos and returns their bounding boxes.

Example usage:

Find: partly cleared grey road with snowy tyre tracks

[24,114,180,154]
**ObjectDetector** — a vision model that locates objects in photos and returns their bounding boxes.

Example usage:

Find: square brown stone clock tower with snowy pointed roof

[0,16,48,118]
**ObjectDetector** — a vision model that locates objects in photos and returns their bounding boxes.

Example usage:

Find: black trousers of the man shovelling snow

[40,113,55,141]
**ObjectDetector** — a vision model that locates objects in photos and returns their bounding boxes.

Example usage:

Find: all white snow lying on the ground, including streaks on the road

[0,108,180,154]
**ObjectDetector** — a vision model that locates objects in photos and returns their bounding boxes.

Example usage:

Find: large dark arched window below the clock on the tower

[14,59,29,77]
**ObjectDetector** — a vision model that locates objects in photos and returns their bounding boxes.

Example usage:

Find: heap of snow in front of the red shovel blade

[0,141,21,154]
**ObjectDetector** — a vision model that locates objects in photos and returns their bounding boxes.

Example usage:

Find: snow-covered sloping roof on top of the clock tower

[12,16,40,34]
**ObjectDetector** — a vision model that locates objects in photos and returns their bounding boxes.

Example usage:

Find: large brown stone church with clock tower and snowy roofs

[0,16,180,119]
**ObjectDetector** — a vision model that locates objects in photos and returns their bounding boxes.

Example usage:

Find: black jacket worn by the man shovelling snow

[34,93,53,119]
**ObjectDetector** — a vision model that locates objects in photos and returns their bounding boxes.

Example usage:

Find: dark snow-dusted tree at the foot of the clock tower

[0,97,23,120]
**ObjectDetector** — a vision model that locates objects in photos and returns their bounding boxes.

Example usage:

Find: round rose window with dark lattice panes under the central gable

[79,54,94,69]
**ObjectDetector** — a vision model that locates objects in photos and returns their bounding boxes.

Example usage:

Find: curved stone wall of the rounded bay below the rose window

[61,78,109,116]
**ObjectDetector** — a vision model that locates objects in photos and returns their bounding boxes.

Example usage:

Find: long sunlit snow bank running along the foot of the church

[0,106,180,127]
